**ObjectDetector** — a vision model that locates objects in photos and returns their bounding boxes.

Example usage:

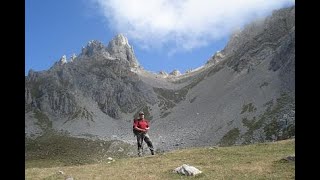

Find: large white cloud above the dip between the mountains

[93,0,294,53]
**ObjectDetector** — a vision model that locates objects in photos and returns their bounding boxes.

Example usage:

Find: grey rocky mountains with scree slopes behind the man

[25,7,295,149]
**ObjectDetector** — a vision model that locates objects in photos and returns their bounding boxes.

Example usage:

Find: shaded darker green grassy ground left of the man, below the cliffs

[25,131,135,168]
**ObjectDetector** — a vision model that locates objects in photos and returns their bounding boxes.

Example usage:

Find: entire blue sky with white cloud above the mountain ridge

[25,0,295,75]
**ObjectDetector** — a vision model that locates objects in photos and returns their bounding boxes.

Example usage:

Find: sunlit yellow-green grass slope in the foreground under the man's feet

[25,139,295,180]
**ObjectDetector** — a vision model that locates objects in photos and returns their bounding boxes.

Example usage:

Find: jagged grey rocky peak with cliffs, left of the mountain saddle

[25,35,156,119]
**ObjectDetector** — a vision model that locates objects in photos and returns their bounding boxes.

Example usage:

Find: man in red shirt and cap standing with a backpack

[133,111,154,156]
